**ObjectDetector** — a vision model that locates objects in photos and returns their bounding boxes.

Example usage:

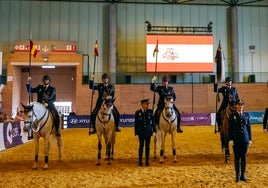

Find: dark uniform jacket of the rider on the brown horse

[218,86,239,109]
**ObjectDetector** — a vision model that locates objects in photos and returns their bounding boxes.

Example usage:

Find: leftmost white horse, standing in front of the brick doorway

[22,102,62,170]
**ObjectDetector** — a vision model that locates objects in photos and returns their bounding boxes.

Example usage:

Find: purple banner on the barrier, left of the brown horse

[181,113,211,125]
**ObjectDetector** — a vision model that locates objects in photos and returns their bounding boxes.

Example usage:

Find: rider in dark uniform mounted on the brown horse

[214,77,239,126]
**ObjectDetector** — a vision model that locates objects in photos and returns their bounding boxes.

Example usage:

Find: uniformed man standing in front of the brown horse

[229,100,252,182]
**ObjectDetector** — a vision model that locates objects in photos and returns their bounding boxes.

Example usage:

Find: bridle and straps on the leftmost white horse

[24,106,49,132]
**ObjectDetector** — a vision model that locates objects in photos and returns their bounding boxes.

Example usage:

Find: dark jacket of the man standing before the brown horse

[229,112,252,143]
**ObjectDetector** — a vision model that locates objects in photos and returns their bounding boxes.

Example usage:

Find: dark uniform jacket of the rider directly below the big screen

[150,83,176,108]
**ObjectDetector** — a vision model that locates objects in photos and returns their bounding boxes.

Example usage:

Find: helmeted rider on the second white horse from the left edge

[89,73,121,134]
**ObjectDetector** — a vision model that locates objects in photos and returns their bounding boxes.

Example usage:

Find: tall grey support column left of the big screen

[108,3,117,83]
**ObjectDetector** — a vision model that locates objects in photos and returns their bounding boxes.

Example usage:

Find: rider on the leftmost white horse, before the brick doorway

[26,75,61,139]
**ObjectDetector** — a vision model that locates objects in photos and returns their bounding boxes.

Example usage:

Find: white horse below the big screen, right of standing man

[154,98,179,163]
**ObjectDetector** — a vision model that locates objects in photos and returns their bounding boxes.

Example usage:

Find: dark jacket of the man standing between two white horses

[134,109,156,137]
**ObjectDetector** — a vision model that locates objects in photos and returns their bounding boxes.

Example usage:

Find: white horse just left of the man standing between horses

[95,98,116,166]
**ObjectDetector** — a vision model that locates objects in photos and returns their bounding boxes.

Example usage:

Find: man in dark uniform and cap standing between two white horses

[134,99,156,166]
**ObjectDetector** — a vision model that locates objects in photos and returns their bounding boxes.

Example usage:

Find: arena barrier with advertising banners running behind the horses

[0,111,264,151]
